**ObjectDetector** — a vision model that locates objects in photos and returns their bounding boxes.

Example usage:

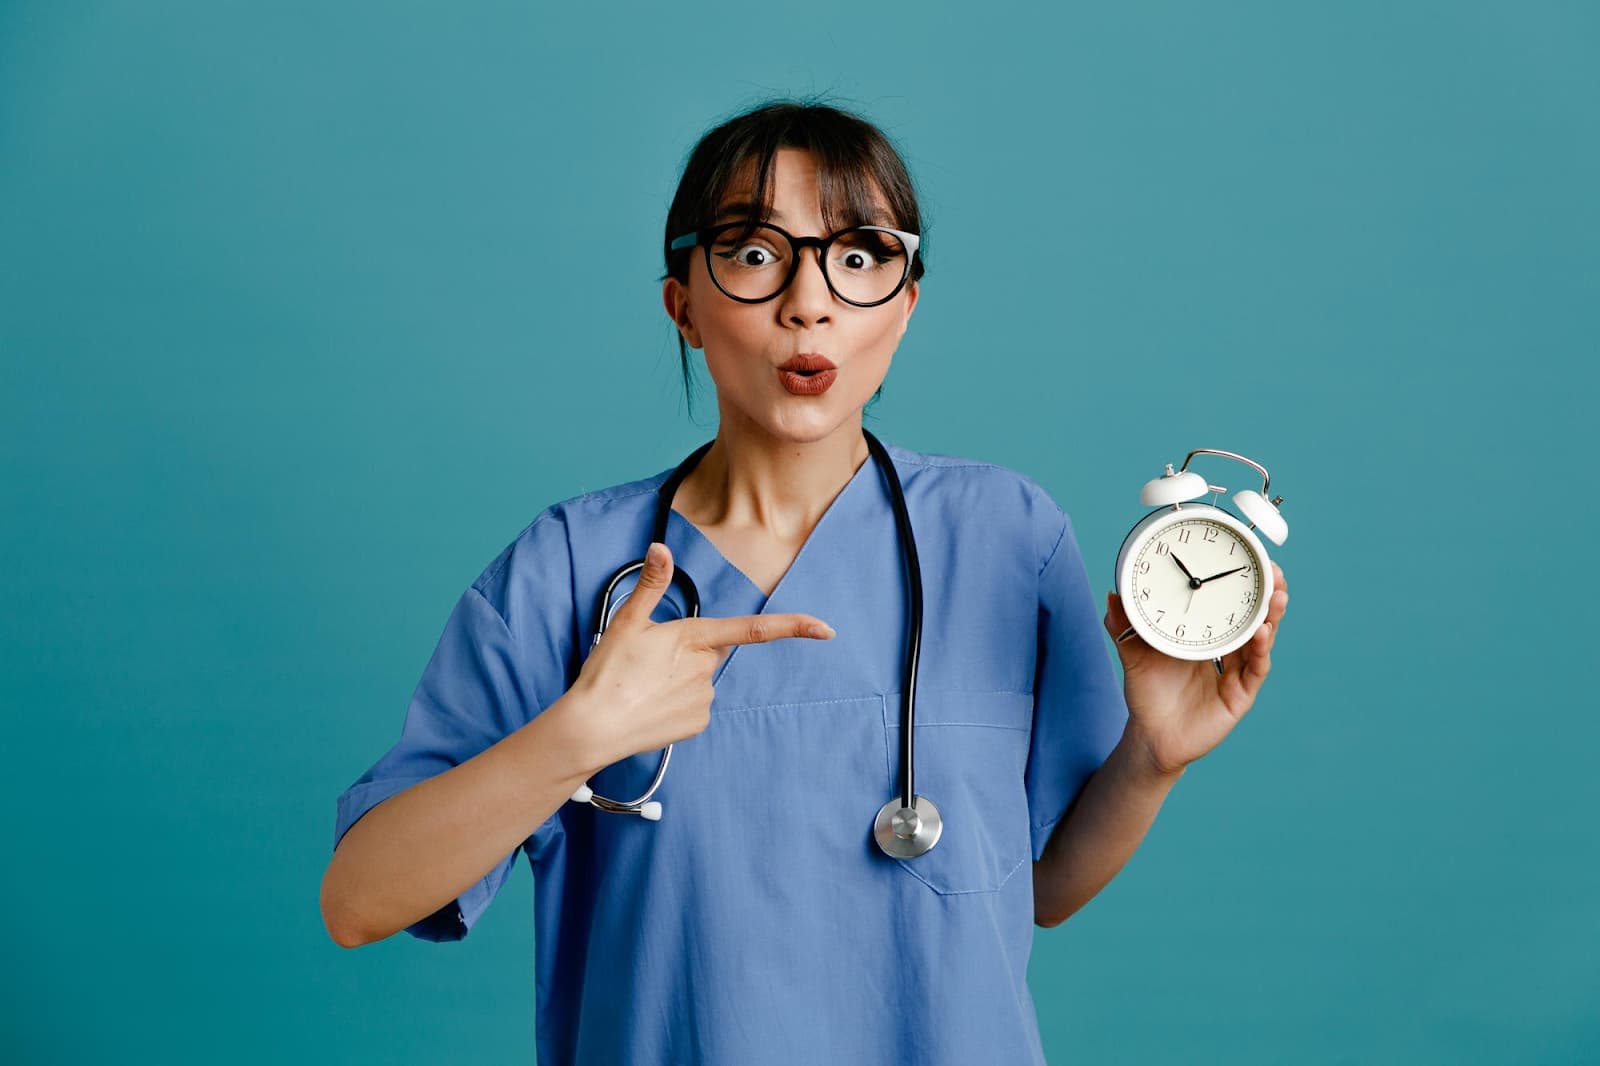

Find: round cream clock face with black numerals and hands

[1125,517,1262,650]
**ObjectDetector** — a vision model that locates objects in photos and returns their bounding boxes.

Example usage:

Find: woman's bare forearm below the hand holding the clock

[1034,722,1182,927]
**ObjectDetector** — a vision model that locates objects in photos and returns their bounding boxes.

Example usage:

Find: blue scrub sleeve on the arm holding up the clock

[1026,504,1128,861]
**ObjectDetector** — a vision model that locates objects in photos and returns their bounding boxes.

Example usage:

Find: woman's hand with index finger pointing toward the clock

[573,543,834,767]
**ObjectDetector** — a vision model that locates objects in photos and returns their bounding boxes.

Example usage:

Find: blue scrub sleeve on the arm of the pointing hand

[333,505,571,941]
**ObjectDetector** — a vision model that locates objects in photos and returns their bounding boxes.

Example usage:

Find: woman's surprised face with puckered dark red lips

[662,149,917,443]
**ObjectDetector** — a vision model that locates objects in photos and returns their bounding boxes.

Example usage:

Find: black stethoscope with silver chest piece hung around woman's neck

[573,429,944,858]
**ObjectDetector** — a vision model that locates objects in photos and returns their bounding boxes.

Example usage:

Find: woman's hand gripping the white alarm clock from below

[1106,563,1290,775]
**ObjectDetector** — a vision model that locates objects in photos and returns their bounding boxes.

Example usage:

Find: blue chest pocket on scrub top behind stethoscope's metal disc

[883,685,1034,895]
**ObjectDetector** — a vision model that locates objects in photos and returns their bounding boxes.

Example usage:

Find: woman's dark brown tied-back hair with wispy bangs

[661,99,926,418]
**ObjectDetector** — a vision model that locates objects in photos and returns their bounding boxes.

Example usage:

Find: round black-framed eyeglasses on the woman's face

[669,221,922,307]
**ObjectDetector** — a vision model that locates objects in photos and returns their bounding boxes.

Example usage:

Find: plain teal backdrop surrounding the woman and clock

[0,2,1600,1064]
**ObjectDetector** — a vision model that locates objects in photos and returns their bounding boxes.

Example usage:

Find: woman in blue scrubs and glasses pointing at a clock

[323,102,1288,1066]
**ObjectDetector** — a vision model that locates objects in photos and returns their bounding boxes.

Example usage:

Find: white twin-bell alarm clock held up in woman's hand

[1117,448,1290,672]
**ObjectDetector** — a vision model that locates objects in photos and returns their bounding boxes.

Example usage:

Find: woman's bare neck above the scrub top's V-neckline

[675,416,870,543]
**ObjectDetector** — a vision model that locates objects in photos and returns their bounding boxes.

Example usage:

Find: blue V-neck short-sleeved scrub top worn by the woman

[334,445,1128,1066]
